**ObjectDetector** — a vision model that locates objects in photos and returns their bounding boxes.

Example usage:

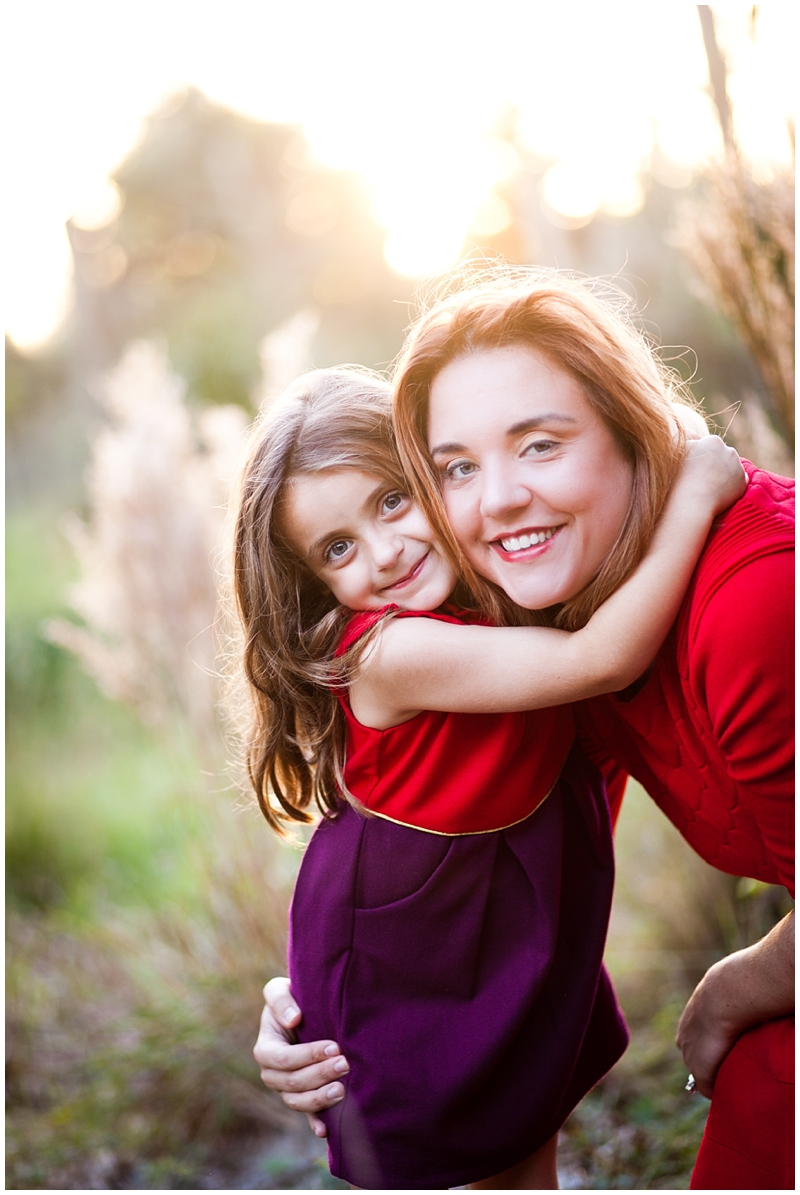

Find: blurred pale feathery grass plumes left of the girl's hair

[48,342,245,746]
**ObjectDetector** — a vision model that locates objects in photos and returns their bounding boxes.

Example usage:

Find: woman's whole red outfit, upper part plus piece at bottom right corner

[575,461,794,1190]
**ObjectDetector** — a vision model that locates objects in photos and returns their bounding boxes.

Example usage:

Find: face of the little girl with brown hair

[282,468,456,609]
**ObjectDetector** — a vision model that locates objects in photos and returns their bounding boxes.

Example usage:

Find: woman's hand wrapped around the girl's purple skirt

[252,979,350,1136]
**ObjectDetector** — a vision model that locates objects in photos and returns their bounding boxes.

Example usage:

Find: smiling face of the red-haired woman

[428,344,633,609]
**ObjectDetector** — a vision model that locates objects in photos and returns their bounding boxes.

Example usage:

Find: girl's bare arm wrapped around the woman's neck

[350,436,746,730]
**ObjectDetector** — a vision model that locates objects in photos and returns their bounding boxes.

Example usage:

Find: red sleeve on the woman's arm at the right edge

[689,551,794,893]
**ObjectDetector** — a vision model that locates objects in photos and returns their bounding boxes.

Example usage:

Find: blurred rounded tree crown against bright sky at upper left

[68,88,410,405]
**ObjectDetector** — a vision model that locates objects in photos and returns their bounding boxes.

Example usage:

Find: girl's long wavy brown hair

[233,367,408,831]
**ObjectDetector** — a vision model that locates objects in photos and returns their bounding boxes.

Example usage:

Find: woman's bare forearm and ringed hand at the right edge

[676,913,794,1099]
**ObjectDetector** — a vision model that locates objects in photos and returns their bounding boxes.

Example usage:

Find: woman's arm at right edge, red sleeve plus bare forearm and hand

[677,551,794,1096]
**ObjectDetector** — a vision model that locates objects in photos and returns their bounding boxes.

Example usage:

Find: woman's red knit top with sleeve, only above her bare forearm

[575,461,794,894]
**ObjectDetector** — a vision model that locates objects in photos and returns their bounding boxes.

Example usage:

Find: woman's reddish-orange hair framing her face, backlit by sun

[395,266,695,630]
